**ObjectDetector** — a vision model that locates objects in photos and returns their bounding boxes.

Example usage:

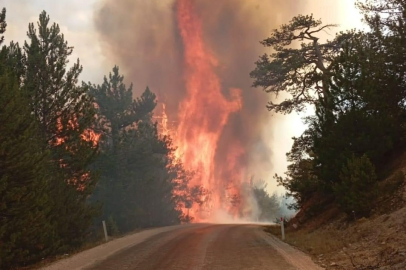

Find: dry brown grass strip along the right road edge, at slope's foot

[265,208,406,270]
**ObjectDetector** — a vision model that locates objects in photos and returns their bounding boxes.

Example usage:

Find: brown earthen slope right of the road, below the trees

[267,161,406,270]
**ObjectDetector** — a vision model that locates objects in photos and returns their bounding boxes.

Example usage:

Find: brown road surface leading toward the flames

[81,224,321,270]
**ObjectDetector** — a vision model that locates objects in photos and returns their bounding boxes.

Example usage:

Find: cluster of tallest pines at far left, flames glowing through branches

[0,10,97,268]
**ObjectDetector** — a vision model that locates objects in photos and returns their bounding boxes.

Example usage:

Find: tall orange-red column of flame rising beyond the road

[174,0,242,221]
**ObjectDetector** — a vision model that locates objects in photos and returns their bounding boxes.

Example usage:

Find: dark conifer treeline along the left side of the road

[0,9,193,269]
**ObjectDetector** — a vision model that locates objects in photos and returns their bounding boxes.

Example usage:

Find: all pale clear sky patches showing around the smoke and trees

[0,0,362,195]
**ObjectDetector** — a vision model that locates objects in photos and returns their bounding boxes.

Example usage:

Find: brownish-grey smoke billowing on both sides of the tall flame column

[95,0,306,185]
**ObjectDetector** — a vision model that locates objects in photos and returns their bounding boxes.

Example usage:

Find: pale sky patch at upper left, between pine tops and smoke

[0,0,114,82]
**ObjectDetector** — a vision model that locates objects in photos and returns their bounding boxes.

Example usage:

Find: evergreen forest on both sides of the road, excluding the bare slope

[0,0,406,269]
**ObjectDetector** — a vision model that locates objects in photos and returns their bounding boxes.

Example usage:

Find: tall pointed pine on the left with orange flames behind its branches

[23,11,97,247]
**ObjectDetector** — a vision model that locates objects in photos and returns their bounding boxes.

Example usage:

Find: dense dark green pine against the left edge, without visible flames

[0,66,58,269]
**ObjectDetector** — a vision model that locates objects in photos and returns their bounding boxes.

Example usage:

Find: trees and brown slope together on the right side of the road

[251,0,406,269]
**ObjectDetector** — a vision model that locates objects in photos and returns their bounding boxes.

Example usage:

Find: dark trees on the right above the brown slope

[251,0,406,217]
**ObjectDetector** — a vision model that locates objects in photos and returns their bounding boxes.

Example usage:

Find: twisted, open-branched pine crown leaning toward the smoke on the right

[251,15,348,113]
